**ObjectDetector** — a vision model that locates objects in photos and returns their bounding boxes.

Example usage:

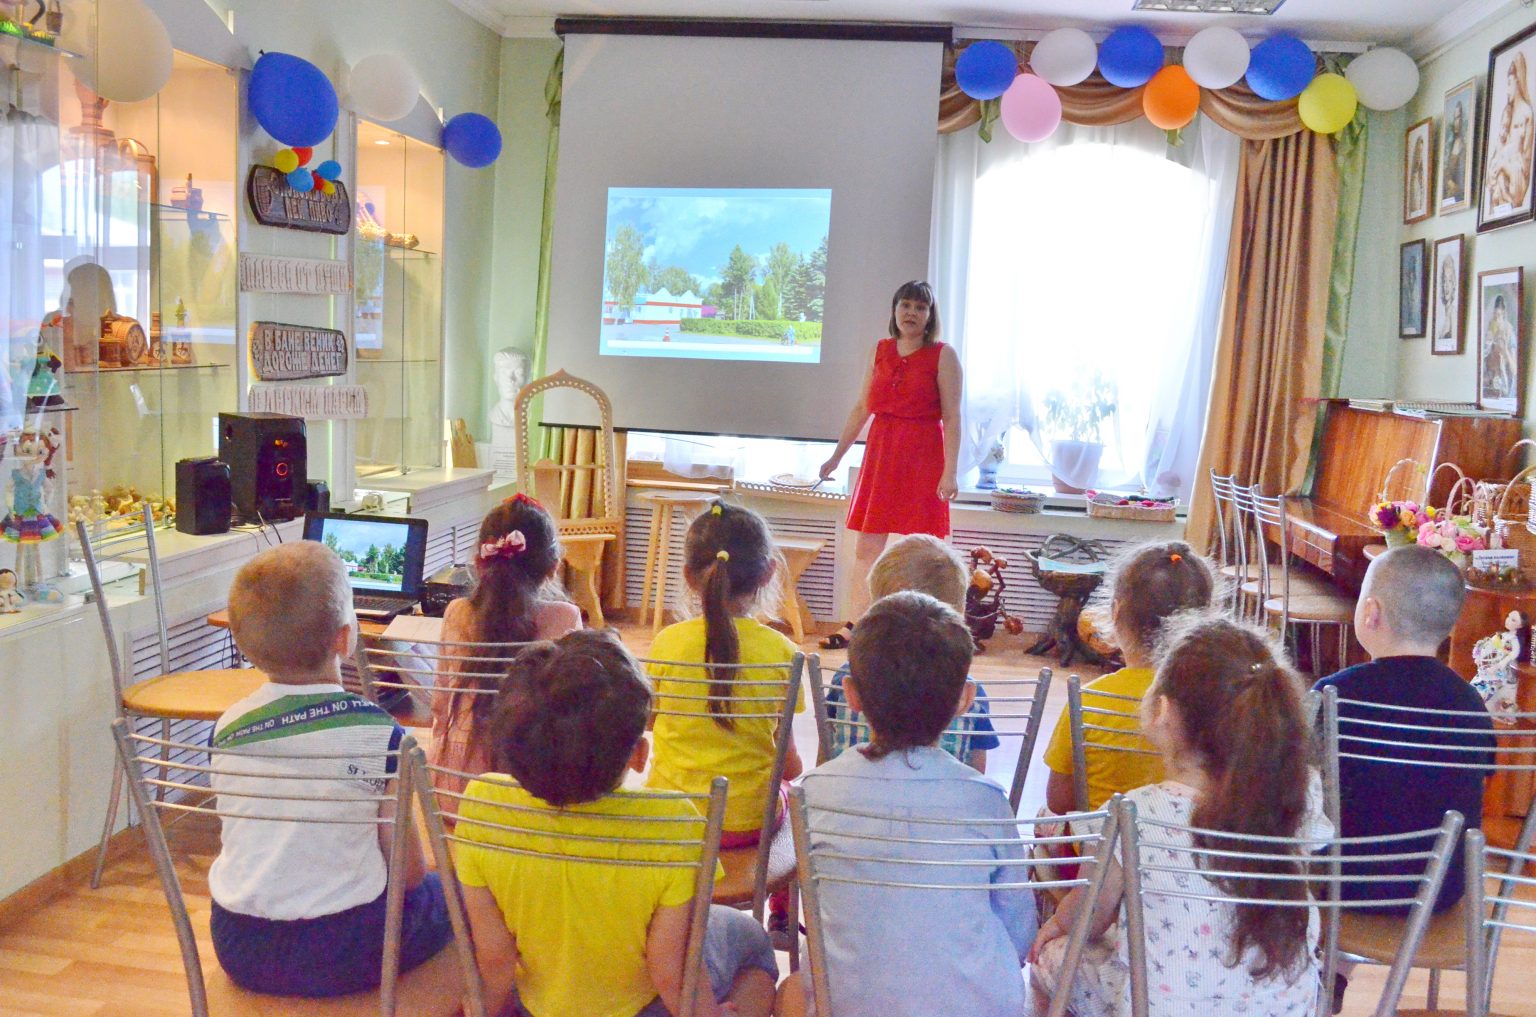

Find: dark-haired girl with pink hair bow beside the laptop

[432,495,581,811]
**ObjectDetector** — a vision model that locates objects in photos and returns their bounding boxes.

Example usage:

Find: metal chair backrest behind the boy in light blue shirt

[790,787,1115,1017]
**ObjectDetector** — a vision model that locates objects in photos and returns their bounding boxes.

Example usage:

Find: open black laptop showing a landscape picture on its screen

[304,512,427,621]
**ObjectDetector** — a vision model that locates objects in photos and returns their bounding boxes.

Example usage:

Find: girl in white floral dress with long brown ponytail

[1031,616,1333,1017]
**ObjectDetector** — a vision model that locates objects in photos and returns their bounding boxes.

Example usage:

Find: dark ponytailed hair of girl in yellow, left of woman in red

[682,501,779,728]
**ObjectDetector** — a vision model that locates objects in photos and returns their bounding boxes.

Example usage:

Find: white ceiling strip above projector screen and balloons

[453,0,1519,54]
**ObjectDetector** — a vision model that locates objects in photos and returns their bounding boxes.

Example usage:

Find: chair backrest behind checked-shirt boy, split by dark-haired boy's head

[809,653,1051,811]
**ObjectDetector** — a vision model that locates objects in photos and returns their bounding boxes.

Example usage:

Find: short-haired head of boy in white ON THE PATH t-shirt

[229,541,356,676]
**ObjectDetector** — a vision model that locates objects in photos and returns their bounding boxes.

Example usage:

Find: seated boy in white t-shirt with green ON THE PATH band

[207,541,453,997]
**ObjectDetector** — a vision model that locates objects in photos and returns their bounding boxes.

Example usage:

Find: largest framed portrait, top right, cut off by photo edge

[1478,25,1536,234]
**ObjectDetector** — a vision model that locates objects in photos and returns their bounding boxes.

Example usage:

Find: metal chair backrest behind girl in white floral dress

[1112,797,1462,1017]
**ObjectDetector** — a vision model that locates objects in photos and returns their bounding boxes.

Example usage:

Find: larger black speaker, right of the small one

[218,413,309,522]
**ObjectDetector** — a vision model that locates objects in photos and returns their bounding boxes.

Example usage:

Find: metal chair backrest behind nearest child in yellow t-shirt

[409,745,727,1017]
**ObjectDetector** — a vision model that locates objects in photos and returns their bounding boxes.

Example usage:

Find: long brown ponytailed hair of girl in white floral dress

[1146,616,1312,979]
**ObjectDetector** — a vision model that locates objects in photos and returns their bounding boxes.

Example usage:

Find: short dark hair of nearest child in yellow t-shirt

[478,628,651,805]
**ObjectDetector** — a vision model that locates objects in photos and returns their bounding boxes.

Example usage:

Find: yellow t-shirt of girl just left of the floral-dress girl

[1043,667,1163,808]
